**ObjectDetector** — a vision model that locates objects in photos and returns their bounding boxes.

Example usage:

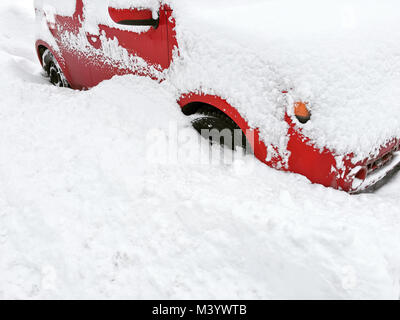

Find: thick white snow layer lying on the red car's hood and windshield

[42,0,400,158]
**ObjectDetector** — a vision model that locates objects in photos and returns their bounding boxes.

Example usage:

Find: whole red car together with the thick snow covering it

[35,0,400,192]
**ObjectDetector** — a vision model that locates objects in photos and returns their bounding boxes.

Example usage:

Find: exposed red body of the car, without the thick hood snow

[35,0,400,193]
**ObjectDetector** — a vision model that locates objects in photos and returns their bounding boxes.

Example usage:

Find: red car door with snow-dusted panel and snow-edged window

[87,0,173,85]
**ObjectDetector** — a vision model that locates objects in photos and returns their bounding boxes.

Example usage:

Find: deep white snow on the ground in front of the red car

[0,0,400,299]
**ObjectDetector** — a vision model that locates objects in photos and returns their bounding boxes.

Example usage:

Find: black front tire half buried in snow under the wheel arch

[192,105,250,151]
